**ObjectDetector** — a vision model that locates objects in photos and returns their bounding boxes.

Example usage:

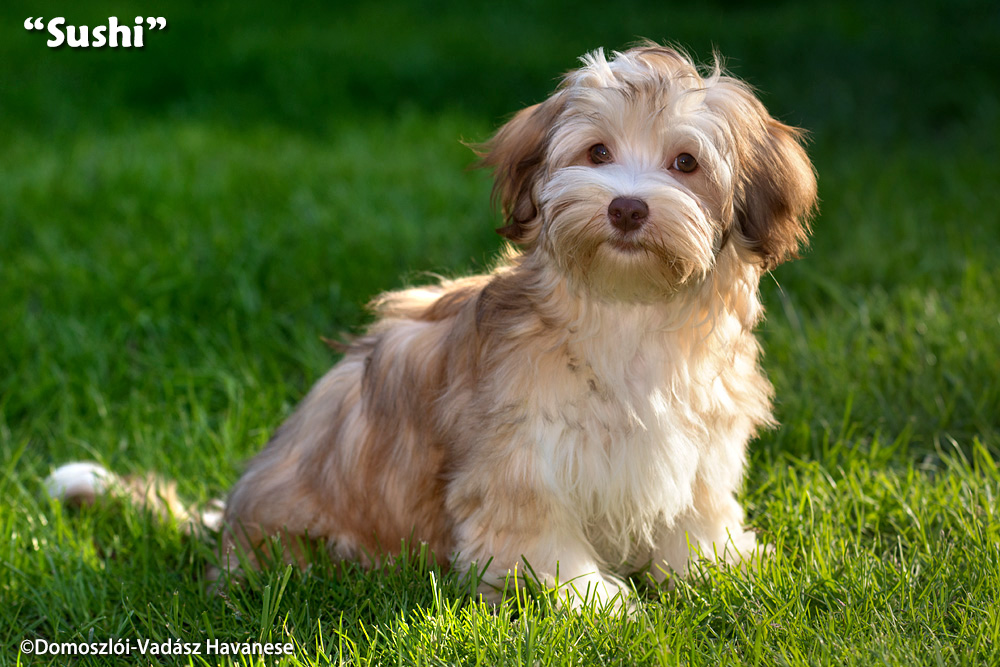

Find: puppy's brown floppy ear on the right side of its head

[736,118,816,271]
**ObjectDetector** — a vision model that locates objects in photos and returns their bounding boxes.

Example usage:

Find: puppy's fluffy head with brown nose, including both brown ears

[483,46,816,301]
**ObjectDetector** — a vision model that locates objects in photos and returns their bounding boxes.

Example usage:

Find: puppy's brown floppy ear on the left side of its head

[476,94,564,248]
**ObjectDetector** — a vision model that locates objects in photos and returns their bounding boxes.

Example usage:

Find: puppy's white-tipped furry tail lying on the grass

[45,462,225,532]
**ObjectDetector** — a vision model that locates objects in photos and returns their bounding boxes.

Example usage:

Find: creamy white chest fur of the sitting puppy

[526,305,768,562]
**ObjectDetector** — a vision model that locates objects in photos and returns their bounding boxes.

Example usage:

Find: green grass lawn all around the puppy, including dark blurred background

[0,1,1000,665]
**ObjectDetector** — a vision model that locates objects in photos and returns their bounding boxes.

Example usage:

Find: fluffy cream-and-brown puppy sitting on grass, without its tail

[48,44,816,605]
